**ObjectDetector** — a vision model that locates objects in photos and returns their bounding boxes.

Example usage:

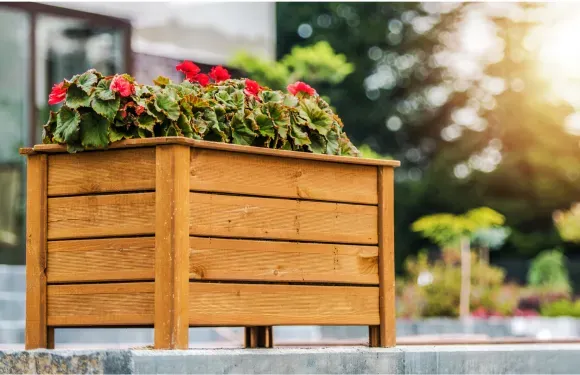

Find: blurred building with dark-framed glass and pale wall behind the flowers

[0,2,276,264]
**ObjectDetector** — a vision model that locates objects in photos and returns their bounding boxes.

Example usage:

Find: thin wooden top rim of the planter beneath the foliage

[19,137,401,167]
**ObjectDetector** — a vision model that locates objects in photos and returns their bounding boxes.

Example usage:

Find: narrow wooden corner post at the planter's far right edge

[378,167,396,347]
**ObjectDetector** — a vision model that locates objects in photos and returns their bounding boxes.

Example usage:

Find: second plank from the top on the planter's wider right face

[190,193,377,245]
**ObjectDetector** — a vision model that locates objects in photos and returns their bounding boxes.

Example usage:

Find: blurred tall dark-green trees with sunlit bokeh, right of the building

[277,2,580,266]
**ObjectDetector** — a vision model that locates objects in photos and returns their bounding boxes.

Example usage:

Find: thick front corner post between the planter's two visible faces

[154,145,190,349]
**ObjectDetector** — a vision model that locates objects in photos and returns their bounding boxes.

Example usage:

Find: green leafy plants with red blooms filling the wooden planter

[43,61,359,156]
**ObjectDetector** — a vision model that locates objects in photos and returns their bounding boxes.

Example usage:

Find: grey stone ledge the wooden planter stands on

[0,344,580,374]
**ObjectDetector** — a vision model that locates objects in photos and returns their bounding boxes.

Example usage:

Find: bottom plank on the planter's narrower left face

[48,282,154,327]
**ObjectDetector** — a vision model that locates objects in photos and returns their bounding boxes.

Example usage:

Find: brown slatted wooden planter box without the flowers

[21,137,399,349]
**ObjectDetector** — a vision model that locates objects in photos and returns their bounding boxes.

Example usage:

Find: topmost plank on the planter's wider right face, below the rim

[190,148,378,204]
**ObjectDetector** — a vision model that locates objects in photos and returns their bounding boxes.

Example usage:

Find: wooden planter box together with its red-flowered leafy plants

[21,63,399,348]
